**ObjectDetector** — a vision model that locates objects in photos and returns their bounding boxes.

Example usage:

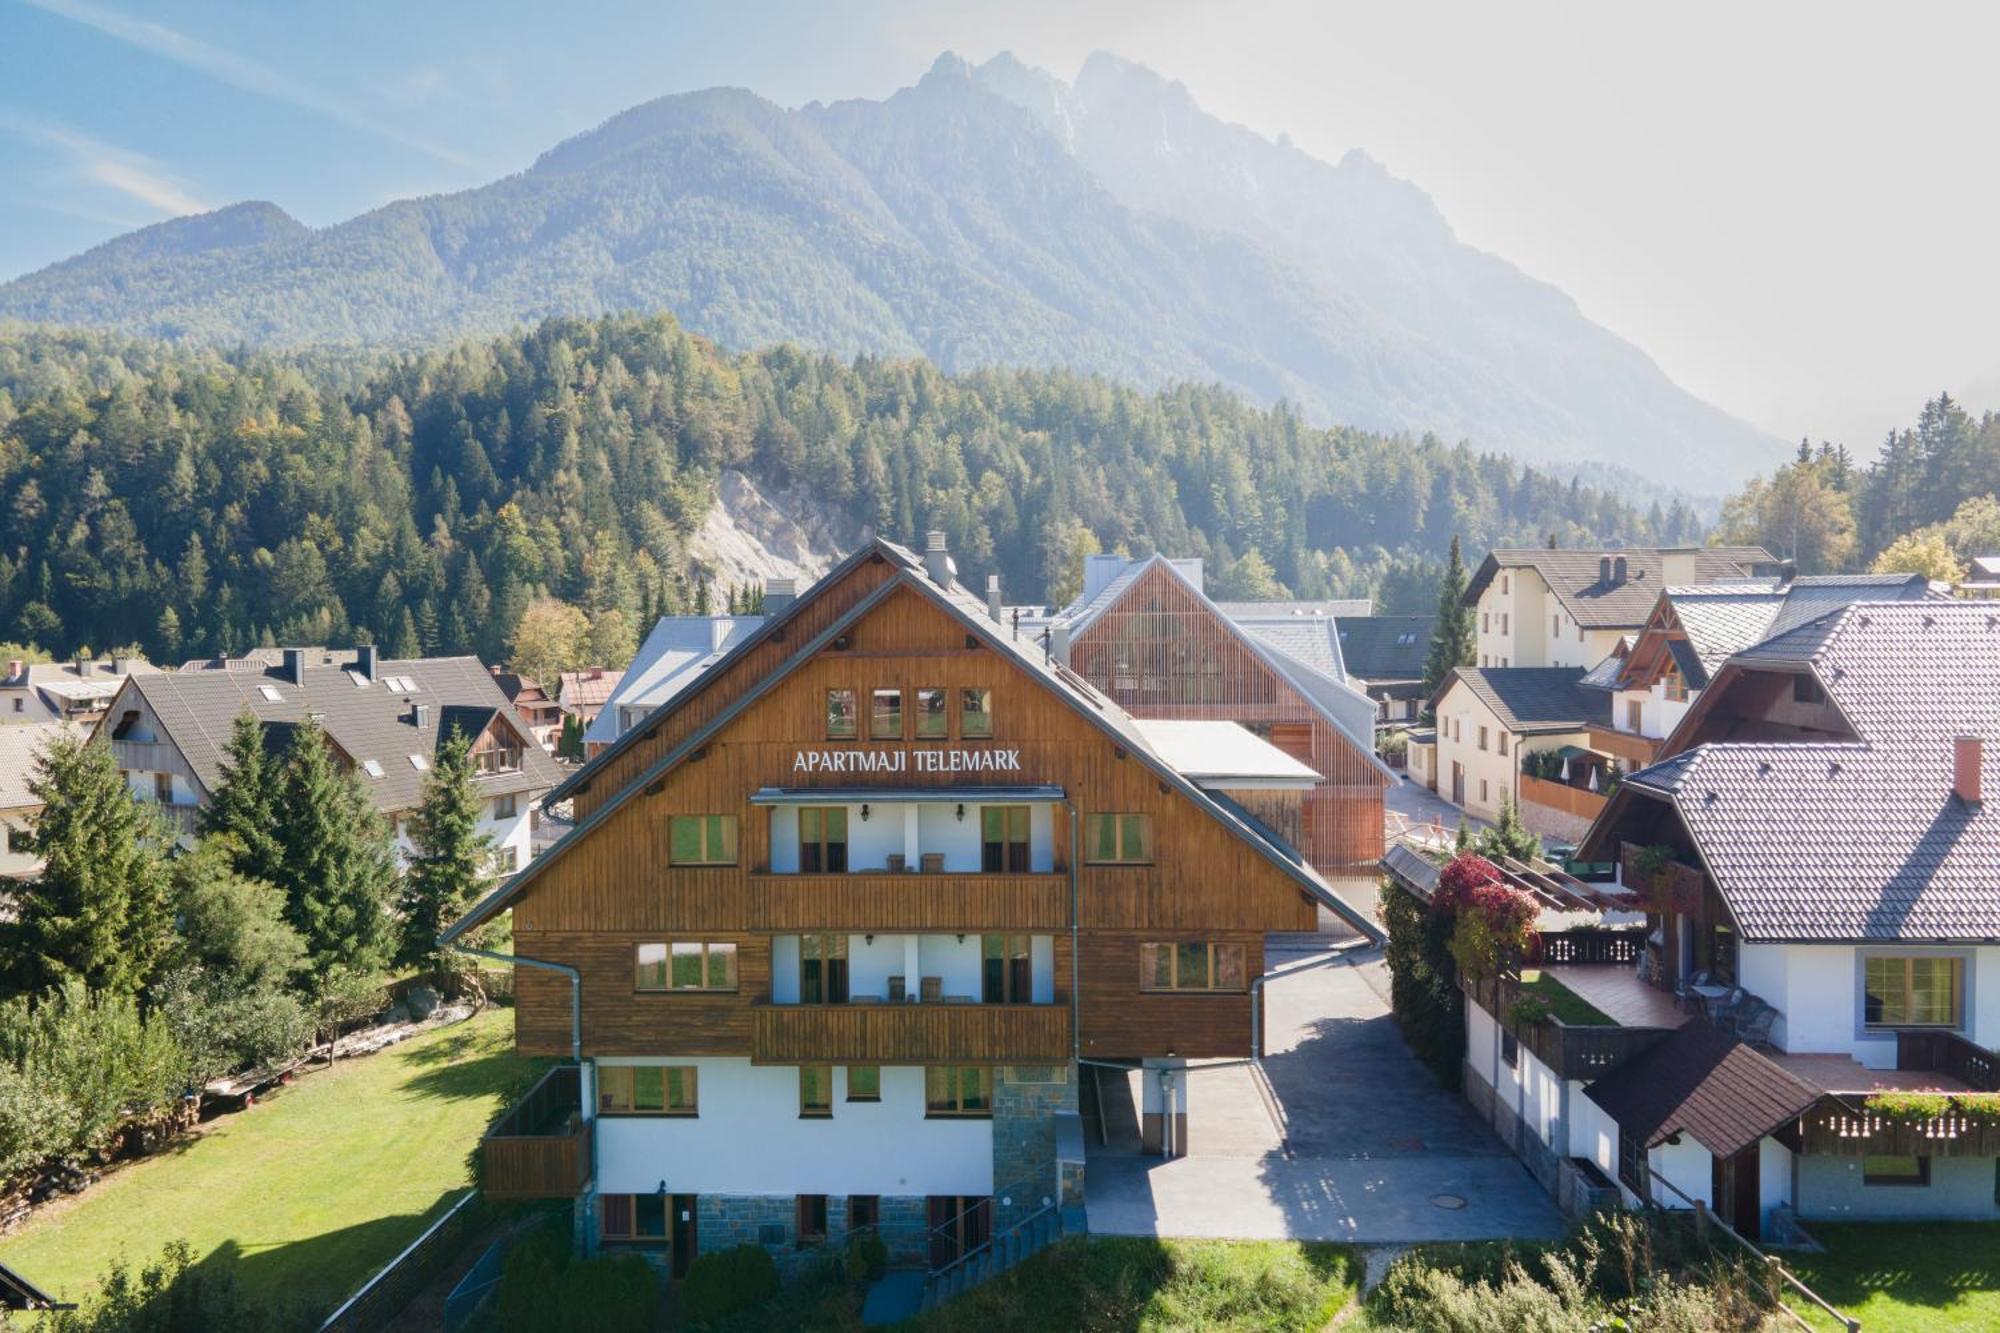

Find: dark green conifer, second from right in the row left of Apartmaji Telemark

[276,719,396,971]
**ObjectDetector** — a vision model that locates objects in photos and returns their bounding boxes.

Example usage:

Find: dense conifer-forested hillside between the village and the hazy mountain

[0,316,1700,660]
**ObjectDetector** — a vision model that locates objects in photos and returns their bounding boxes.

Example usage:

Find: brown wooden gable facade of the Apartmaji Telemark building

[500,564,1320,1063]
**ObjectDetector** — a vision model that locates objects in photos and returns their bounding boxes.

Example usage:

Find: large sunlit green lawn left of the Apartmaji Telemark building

[0,1009,538,1313]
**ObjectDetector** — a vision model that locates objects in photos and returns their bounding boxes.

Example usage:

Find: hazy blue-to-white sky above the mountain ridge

[0,0,2000,450]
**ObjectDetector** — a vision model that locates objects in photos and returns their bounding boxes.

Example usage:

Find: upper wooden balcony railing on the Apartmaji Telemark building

[744,871,1070,933]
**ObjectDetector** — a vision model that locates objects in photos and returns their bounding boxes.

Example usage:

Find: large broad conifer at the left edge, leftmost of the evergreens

[6,737,172,995]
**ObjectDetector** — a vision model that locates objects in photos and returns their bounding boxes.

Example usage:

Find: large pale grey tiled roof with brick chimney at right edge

[1606,602,2000,941]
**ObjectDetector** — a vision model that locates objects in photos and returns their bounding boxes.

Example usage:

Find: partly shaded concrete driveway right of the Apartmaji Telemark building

[1086,935,1562,1243]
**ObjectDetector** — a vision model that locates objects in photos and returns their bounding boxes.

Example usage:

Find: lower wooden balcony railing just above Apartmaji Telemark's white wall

[750,1003,1070,1065]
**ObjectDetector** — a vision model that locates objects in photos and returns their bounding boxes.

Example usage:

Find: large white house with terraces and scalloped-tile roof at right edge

[1388,602,2000,1239]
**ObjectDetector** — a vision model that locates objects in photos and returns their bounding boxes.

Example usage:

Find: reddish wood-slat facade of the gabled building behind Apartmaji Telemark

[1070,566,1386,875]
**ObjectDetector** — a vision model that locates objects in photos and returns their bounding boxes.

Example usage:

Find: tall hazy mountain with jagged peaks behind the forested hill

[0,56,1782,486]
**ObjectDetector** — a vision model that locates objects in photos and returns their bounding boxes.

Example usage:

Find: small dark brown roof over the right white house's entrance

[1584,1021,1820,1160]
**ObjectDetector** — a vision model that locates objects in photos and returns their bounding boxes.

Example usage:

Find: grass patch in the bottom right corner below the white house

[1784,1221,2000,1333]
